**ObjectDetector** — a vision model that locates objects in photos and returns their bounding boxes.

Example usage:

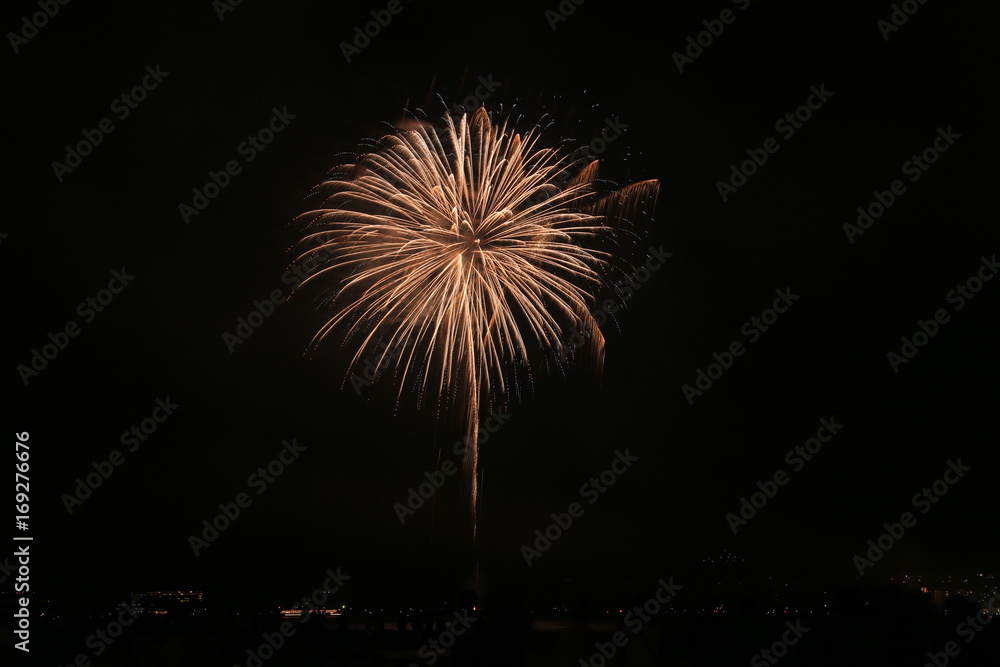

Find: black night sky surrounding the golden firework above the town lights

[7,0,1000,616]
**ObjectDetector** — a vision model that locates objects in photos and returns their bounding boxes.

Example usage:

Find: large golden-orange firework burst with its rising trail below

[296,109,659,532]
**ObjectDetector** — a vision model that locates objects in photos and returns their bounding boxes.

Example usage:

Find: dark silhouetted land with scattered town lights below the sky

[9,584,1000,667]
